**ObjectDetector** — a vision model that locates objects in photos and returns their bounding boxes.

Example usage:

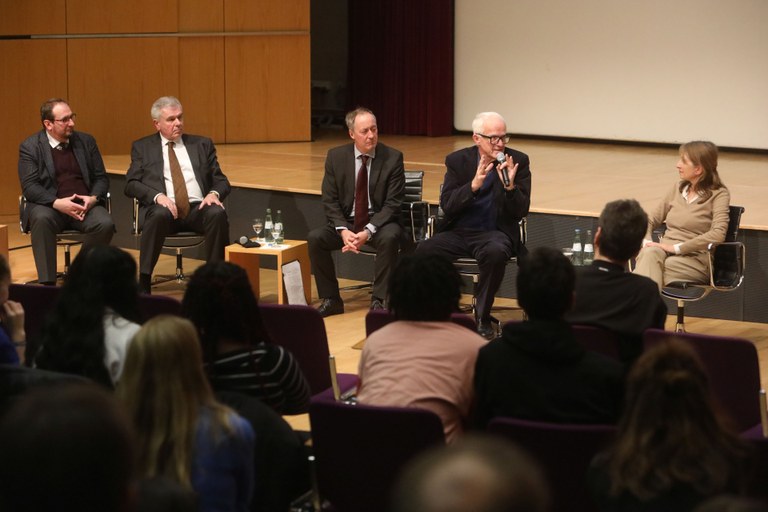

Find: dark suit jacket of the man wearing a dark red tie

[322,143,405,229]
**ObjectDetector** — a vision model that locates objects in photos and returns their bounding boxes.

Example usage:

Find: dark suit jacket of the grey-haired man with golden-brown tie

[125,133,231,211]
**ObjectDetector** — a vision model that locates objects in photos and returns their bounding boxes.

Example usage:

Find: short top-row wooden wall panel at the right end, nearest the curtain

[224,0,309,31]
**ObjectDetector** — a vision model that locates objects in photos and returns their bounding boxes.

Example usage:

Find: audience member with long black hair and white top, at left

[35,245,140,388]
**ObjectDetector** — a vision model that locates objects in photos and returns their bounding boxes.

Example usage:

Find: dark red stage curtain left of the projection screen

[348,0,454,136]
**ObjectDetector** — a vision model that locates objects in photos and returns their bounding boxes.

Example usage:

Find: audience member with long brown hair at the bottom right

[588,341,746,512]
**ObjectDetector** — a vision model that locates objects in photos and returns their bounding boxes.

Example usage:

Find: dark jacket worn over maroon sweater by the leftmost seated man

[19,130,109,229]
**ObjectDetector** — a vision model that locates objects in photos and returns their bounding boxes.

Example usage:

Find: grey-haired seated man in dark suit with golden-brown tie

[125,96,230,293]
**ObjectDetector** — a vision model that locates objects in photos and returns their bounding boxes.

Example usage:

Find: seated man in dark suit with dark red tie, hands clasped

[308,108,405,316]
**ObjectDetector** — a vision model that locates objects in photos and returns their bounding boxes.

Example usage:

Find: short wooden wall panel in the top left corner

[0,0,66,36]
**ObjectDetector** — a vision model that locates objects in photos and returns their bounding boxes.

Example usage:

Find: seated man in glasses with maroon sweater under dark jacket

[19,98,115,284]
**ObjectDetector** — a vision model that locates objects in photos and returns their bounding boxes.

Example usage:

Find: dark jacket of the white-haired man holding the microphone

[440,146,531,255]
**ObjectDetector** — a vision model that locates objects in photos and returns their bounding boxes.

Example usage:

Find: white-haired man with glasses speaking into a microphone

[418,112,531,338]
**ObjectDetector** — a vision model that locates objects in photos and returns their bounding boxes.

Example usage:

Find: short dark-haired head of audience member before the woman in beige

[595,199,648,263]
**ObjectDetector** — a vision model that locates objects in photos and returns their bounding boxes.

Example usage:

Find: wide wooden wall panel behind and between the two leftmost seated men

[69,37,179,154]
